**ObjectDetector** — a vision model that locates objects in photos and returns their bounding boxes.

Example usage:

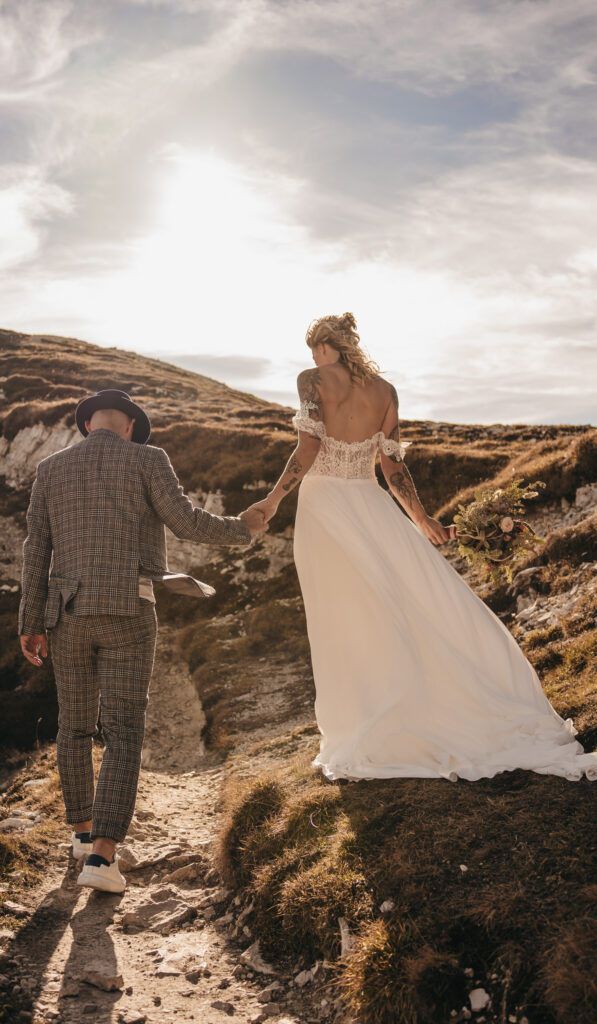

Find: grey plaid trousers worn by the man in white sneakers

[48,599,158,843]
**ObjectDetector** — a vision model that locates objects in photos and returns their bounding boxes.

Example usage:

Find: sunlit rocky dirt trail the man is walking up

[0,629,322,1024]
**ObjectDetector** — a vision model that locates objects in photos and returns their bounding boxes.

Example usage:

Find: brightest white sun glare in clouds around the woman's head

[37,148,516,411]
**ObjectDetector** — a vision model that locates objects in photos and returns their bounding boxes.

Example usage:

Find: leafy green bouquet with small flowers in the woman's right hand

[454,479,546,584]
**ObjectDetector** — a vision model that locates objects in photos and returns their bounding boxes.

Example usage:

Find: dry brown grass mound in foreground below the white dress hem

[219,749,597,1024]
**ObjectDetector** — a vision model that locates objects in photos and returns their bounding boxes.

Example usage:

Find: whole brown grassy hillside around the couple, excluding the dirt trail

[0,332,597,1024]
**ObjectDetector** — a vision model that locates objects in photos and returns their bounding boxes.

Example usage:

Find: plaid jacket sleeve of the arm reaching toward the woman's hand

[150,449,251,544]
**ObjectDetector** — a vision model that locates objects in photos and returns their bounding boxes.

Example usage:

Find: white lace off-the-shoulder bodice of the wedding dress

[292,402,412,480]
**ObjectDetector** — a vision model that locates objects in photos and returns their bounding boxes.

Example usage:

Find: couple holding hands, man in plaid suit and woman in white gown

[18,313,597,892]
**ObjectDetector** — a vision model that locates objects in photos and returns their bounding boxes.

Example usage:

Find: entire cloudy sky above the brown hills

[0,0,597,424]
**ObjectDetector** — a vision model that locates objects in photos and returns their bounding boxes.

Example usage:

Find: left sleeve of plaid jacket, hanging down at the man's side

[18,472,52,636]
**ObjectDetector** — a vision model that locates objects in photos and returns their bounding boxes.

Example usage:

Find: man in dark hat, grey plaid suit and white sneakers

[18,390,267,892]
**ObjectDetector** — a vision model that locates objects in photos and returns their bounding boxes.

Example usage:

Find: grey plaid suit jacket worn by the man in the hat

[18,429,251,636]
